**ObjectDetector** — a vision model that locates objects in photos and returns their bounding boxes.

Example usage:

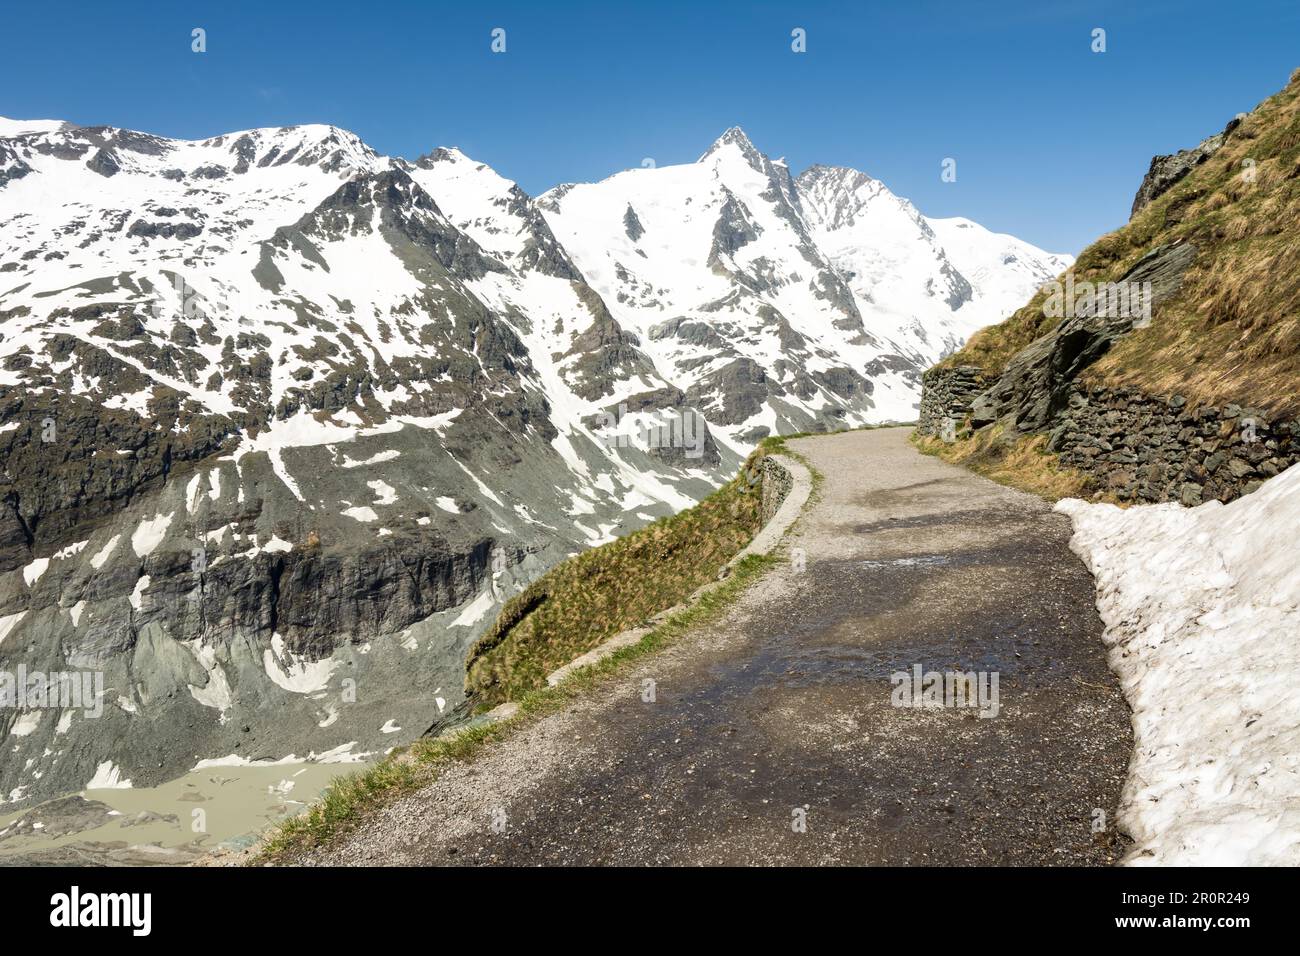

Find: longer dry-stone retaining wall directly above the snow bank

[1048,388,1300,506]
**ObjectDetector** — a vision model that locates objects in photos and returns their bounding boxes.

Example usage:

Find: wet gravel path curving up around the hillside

[289,428,1132,865]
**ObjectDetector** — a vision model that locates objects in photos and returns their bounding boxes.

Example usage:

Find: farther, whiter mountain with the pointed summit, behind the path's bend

[538,129,1073,426]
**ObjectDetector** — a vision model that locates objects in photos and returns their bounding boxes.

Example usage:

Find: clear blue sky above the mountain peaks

[0,0,1300,252]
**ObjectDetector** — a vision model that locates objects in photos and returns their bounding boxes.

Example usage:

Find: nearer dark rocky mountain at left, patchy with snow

[0,119,740,804]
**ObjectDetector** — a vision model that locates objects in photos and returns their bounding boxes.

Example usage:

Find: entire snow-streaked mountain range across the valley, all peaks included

[0,120,1067,803]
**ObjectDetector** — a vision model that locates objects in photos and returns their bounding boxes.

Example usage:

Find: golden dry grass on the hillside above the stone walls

[943,70,1300,416]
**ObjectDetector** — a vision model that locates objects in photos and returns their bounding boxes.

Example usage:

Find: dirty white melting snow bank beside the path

[1057,467,1300,866]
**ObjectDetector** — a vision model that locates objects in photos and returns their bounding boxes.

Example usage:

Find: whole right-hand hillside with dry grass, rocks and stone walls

[922,70,1300,505]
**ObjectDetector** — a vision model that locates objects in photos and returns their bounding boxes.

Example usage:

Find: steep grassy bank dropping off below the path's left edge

[465,445,785,710]
